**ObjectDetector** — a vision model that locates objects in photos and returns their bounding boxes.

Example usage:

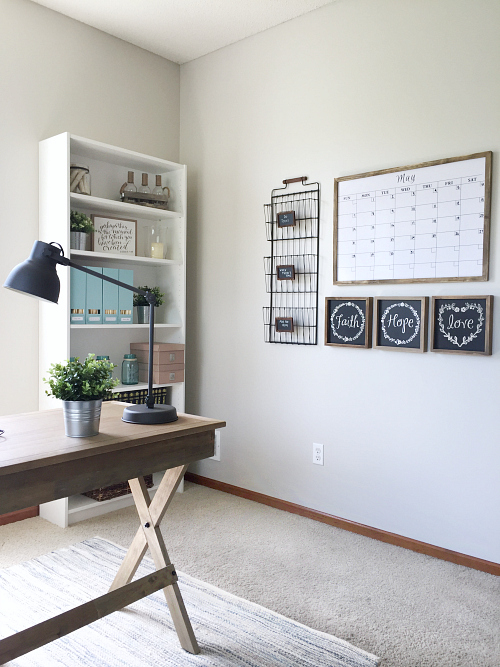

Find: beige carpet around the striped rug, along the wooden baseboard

[0,484,500,667]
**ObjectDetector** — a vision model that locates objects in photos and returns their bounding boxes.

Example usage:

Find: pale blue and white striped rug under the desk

[0,537,380,667]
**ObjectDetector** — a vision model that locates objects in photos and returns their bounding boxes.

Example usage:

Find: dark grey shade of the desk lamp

[4,241,60,303]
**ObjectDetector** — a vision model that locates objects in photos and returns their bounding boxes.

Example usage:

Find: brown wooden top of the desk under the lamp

[0,401,226,484]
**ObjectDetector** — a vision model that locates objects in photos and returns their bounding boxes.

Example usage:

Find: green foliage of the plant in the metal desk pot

[43,354,118,401]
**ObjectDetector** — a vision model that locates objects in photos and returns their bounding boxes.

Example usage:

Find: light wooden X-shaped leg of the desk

[110,465,200,653]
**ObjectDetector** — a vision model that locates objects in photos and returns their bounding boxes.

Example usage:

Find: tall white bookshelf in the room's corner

[39,132,186,526]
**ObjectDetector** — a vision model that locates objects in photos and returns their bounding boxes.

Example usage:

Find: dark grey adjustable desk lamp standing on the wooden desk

[4,241,177,424]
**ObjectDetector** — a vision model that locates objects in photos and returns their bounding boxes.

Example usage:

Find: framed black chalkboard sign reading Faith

[325,297,372,348]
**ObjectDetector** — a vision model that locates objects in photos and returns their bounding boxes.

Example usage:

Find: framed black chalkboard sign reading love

[431,296,493,354]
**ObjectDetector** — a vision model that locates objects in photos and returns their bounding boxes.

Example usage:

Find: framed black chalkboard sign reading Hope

[374,296,428,352]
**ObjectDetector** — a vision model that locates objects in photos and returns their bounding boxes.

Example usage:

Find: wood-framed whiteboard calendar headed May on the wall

[333,152,491,284]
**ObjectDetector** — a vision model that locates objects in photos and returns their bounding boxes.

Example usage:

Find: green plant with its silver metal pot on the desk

[44,354,118,438]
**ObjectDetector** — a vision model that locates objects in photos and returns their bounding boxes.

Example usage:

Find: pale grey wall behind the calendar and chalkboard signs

[181,0,500,562]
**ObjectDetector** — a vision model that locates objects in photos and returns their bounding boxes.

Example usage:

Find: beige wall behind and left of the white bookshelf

[0,0,179,418]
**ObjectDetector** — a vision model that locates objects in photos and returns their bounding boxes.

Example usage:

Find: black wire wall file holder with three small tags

[263,176,320,345]
